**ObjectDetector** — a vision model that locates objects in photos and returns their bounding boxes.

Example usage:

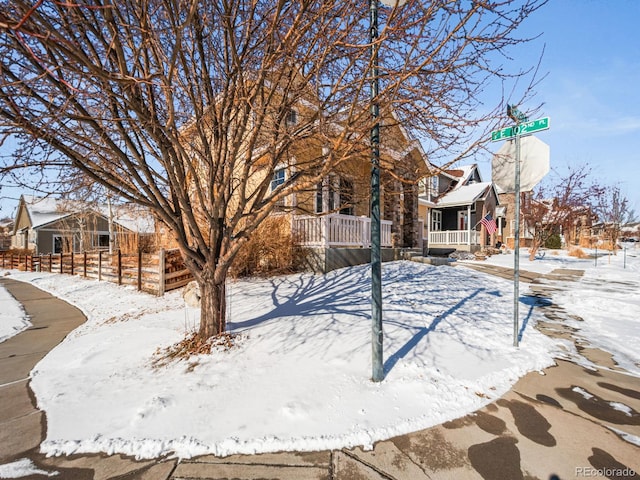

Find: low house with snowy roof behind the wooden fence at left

[11,195,155,254]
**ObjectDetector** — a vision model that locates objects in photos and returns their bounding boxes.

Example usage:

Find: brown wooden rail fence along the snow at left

[0,250,193,296]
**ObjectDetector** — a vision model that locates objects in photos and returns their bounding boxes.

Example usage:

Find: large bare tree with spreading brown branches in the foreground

[0,0,544,338]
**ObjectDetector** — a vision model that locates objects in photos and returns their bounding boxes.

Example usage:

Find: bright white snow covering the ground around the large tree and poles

[0,251,640,458]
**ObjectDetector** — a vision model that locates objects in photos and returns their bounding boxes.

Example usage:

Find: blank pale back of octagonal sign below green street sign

[491,135,550,193]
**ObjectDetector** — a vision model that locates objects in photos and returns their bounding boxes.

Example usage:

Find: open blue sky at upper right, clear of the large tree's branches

[480,0,640,217]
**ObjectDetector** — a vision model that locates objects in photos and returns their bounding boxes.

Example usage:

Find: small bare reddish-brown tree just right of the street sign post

[521,165,604,260]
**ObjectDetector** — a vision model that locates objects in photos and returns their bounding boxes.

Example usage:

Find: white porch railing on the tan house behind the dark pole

[292,213,392,248]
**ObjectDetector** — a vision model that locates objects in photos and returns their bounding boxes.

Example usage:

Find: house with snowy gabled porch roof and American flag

[419,164,504,252]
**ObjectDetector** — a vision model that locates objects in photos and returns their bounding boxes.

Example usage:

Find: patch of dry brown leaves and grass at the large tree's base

[151,332,242,371]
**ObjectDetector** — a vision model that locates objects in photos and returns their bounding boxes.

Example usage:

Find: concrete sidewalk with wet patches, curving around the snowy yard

[0,265,640,480]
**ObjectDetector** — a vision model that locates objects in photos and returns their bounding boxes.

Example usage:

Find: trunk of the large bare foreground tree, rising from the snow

[198,274,227,340]
